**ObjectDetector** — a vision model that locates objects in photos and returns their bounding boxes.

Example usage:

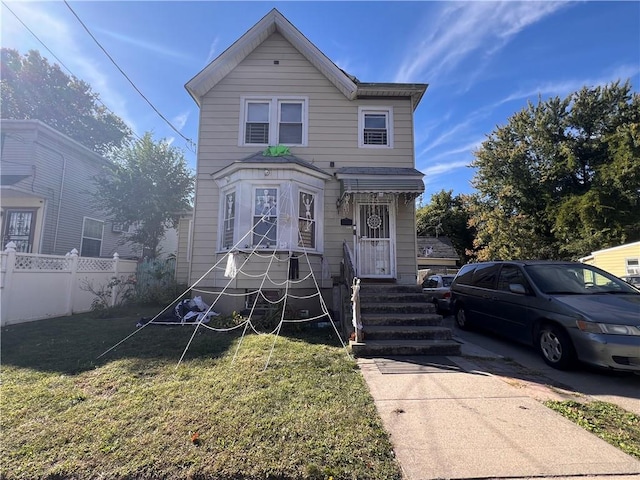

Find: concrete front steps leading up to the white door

[350,283,461,357]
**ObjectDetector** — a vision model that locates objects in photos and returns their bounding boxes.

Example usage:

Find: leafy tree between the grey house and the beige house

[93,132,194,258]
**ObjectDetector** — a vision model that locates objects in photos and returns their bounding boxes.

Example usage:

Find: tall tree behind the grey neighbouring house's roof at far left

[0,48,132,154]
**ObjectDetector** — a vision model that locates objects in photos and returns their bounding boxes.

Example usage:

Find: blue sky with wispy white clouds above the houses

[1,0,640,201]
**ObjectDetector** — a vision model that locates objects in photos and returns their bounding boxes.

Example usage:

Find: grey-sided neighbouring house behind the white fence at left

[0,119,140,258]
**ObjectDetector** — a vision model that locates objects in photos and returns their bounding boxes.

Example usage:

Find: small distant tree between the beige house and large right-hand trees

[416,189,474,262]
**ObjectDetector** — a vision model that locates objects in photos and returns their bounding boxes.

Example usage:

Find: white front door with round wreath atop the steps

[356,203,396,278]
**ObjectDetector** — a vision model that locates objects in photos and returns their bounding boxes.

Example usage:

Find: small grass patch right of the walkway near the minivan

[544,401,640,459]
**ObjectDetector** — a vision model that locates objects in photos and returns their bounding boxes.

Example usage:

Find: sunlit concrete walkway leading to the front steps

[358,343,640,480]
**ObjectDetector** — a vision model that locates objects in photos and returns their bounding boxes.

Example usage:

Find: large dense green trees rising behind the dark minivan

[469,81,640,260]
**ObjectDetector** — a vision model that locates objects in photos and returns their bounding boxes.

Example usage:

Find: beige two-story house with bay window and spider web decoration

[179,9,427,311]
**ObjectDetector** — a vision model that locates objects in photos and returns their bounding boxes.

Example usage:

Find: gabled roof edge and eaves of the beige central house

[185,8,427,109]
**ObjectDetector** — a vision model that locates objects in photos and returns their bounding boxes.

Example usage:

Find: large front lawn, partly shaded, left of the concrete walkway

[0,315,401,480]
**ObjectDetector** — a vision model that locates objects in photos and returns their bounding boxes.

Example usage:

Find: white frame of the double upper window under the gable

[238,96,309,147]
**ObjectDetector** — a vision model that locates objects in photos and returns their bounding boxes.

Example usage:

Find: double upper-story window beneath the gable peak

[239,97,308,146]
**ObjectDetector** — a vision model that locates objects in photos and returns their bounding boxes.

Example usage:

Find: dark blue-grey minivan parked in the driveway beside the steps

[451,261,640,372]
